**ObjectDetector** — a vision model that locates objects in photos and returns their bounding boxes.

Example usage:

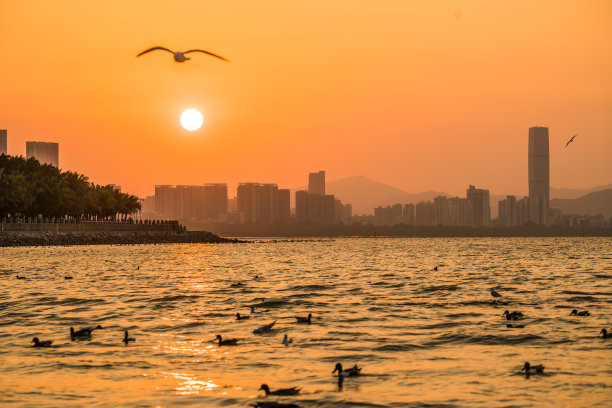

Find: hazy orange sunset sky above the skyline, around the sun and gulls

[0,0,612,196]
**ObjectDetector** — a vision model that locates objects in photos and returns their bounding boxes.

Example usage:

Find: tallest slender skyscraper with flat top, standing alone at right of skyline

[529,127,550,225]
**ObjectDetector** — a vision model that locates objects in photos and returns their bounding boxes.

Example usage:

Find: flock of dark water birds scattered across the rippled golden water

[22,266,612,408]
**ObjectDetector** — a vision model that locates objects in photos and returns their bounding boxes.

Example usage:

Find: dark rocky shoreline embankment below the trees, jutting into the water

[0,231,244,247]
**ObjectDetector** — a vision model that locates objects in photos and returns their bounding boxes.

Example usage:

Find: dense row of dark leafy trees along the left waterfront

[0,154,140,220]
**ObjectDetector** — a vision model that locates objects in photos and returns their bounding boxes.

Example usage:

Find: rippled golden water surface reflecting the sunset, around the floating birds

[0,238,612,407]
